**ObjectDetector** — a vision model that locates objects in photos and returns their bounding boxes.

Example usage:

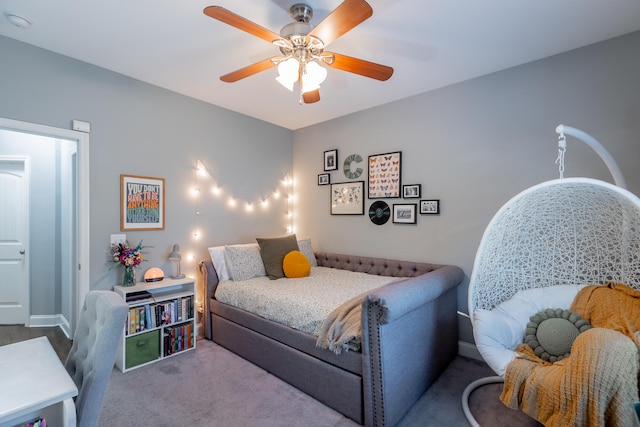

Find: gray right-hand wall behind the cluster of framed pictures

[294,33,640,342]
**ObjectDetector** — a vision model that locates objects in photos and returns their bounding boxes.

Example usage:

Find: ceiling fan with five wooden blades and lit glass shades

[204,0,393,104]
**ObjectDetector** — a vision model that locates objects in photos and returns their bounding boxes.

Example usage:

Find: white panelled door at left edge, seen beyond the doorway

[0,157,29,325]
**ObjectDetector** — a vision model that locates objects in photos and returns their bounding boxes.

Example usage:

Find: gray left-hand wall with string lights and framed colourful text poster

[0,37,293,306]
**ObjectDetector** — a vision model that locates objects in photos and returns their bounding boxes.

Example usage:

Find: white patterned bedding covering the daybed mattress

[215,267,402,337]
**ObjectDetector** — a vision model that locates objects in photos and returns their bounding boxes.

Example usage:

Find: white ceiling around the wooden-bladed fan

[0,0,640,129]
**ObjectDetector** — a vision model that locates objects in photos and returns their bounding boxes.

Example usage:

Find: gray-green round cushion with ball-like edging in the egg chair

[524,308,591,362]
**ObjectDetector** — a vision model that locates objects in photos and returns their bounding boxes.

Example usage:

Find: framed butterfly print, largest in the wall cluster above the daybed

[368,151,402,199]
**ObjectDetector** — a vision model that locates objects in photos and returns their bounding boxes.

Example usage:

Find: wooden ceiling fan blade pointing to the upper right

[309,0,373,46]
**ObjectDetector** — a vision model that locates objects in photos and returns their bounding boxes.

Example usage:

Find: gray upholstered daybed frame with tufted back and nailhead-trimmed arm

[198,246,464,426]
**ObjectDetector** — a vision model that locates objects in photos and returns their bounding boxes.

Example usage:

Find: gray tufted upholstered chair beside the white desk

[64,291,129,427]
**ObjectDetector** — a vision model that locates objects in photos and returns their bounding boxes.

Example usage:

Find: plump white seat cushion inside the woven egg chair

[473,285,585,376]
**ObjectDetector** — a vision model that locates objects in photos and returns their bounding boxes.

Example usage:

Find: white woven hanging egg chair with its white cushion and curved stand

[462,125,640,427]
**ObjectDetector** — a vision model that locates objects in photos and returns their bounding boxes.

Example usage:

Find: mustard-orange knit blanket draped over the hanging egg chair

[500,283,640,427]
